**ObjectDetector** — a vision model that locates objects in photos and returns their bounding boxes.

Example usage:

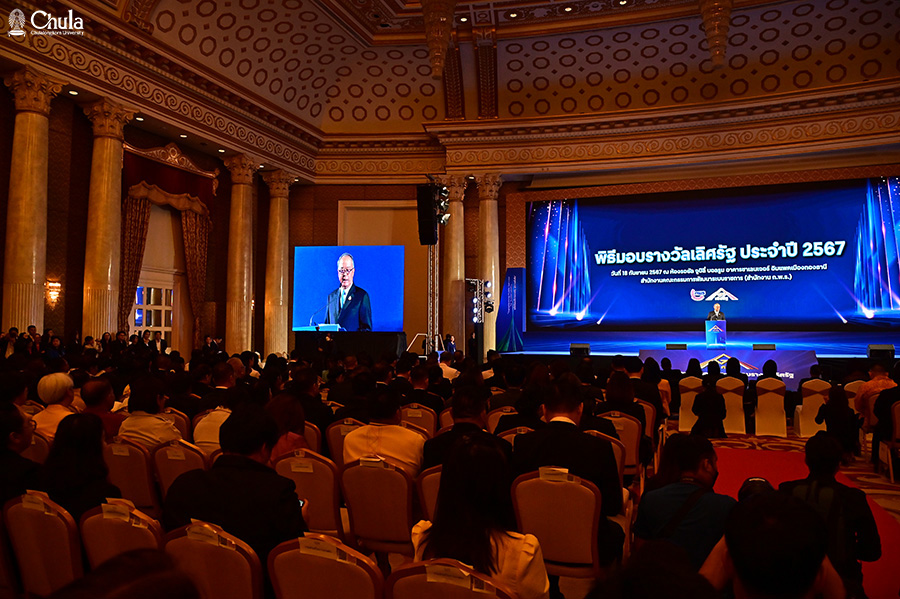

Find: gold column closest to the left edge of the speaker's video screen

[263,170,294,355]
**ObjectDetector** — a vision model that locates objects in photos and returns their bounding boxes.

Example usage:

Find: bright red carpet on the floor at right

[716,447,900,599]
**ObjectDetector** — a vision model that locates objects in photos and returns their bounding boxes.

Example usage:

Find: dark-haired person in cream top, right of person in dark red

[119,376,181,449]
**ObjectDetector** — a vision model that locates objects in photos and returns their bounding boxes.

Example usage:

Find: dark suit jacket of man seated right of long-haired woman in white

[513,421,622,516]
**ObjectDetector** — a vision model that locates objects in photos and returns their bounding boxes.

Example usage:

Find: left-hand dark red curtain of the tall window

[119,196,150,331]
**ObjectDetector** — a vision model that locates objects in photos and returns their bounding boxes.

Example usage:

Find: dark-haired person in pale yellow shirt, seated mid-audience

[344,385,425,478]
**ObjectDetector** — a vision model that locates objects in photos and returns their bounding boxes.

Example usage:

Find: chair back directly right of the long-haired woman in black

[103,437,162,518]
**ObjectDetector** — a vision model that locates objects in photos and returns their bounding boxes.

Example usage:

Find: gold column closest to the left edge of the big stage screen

[476,173,503,352]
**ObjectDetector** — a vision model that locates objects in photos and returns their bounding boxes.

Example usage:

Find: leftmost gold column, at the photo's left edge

[3,67,65,331]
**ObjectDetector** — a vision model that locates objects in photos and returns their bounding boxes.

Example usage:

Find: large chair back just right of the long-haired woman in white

[512,468,601,578]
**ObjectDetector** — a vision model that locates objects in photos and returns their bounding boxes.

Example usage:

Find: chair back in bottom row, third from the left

[165,522,262,599]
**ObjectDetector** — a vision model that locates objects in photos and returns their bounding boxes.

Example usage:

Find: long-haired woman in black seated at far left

[35,414,122,522]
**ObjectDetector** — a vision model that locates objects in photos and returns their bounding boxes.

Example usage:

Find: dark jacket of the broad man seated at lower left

[163,454,307,563]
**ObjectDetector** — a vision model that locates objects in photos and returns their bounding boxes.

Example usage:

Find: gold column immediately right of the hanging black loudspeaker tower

[436,175,468,351]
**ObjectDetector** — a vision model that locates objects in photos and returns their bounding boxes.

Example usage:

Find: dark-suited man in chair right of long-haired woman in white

[513,387,625,568]
